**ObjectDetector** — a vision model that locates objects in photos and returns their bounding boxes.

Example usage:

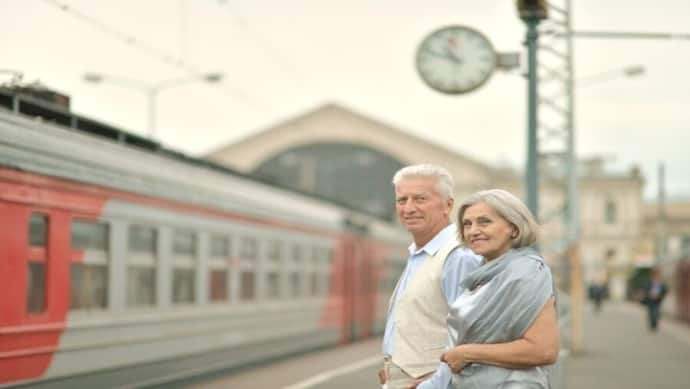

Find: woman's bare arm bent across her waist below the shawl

[441,297,559,373]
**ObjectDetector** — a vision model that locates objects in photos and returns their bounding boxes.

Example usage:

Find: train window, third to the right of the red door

[172,230,197,304]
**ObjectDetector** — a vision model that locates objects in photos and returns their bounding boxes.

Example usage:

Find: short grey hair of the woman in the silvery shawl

[458,189,539,248]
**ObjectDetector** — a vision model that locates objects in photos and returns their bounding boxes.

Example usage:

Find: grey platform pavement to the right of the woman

[565,301,690,389]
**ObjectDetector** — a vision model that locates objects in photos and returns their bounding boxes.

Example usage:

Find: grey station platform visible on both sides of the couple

[190,303,690,389]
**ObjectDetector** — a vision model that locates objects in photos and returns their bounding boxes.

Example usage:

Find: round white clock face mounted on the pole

[417,26,496,94]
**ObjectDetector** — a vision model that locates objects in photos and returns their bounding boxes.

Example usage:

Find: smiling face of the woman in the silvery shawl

[462,202,517,261]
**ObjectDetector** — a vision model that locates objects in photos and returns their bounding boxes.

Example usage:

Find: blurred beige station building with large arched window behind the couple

[206,104,644,298]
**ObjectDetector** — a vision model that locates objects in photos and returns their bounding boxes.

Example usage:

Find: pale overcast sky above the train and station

[0,0,690,199]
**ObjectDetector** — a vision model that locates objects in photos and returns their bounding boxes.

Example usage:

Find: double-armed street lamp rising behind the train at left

[83,72,223,139]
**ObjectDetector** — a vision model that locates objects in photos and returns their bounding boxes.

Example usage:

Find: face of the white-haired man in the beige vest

[395,177,453,241]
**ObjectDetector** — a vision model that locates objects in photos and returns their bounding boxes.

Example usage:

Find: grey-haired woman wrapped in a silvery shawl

[441,189,559,389]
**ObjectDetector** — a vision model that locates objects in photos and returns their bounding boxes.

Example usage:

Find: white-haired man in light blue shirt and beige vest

[379,164,481,389]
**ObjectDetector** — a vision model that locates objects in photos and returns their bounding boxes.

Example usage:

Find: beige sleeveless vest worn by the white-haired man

[388,238,460,378]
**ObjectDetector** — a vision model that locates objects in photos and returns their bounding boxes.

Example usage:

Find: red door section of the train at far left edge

[0,202,70,384]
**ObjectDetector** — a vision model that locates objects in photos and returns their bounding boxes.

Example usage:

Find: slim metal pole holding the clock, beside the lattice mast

[525,18,539,219]
